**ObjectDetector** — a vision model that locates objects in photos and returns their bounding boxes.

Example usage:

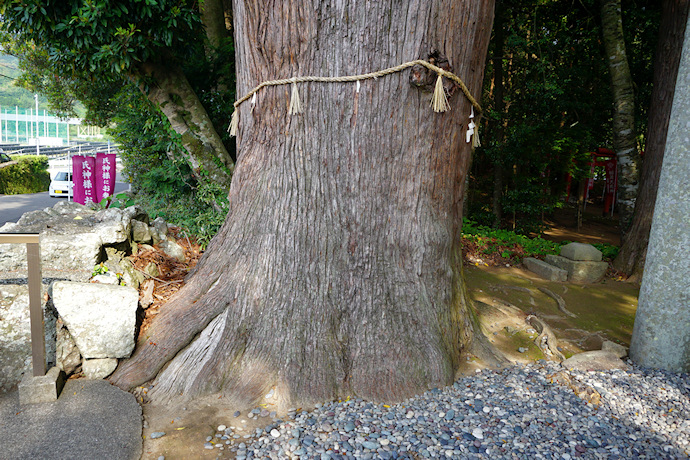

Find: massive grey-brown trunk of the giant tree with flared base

[111,0,493,407]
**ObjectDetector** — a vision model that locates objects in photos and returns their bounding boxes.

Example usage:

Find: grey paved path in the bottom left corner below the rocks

[0,379,142,460]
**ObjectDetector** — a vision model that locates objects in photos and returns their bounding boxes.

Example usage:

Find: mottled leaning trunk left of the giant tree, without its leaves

[142,58,235,188]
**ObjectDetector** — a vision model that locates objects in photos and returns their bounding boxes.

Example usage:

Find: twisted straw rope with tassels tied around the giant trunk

[228,59,482,147]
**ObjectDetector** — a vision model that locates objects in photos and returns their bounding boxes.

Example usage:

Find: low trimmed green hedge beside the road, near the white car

[0,155,50,195]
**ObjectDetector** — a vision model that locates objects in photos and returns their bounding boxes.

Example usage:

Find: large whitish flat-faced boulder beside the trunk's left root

[51,281,139,359]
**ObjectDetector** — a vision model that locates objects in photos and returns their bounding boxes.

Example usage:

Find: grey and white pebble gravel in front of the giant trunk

[202,362,690,460]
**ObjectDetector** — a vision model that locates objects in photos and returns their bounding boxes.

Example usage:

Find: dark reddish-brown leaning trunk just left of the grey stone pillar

[613,0,690,281]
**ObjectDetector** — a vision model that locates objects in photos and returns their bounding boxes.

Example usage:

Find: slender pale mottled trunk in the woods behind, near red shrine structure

[601,0,639,235]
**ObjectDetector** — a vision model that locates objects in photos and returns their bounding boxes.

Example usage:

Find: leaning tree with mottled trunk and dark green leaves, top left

[0,0,234,188]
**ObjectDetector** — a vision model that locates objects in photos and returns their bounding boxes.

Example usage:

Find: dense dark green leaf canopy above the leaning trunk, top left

[0,0,201,74]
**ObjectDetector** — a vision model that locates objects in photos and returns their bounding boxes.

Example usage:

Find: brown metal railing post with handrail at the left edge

[0,233,46,377]
